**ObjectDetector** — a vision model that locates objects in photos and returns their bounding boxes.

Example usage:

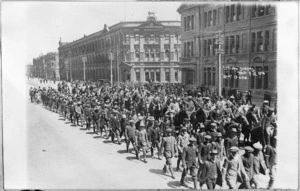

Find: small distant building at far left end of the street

[33,52,60,80]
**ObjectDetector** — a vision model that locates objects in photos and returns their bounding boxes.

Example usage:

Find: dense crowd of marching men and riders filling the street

[30,81,277,189]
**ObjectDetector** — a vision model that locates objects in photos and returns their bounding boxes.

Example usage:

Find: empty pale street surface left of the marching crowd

[5,80,268,189]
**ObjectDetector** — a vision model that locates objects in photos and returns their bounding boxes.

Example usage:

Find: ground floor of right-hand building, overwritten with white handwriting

[179,54,277,100]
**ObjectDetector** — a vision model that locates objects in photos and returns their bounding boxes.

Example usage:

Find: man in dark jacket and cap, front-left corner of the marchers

[180,137,198,189]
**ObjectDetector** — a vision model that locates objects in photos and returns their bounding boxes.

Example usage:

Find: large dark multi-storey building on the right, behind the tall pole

[177,3,277,98]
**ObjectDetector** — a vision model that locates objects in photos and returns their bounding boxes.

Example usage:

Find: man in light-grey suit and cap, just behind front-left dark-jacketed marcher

[161,128,178,179]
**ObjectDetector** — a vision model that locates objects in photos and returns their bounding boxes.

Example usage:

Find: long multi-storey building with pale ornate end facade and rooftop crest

[58,12,181,83]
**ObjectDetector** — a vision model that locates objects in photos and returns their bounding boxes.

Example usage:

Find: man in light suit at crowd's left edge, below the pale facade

[137,121,149,163]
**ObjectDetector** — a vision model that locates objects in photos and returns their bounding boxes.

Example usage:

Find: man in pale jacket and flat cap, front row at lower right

[222,146,249,189]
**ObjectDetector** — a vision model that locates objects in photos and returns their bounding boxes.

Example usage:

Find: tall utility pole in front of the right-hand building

[216,30,224,98]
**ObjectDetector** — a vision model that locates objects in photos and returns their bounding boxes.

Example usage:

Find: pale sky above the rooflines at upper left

[2,2,180,65]
